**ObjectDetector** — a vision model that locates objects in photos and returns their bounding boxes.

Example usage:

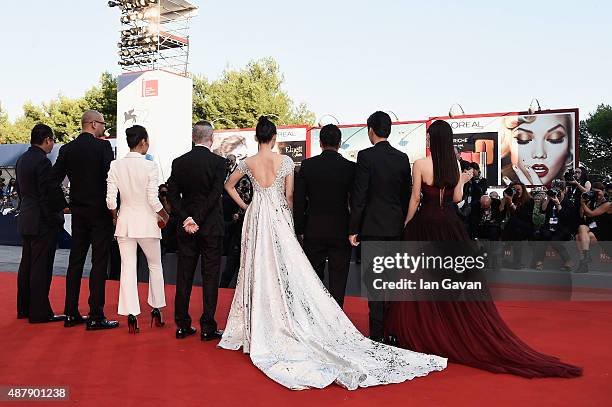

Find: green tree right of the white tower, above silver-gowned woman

[193,58,315,128]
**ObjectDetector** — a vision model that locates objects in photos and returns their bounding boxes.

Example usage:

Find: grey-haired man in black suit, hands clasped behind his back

[168,121,227,341]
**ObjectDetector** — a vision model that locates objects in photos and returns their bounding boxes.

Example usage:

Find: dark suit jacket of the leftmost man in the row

[15,146,64,235]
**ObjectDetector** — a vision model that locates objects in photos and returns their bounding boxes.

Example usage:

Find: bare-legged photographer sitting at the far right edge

[576,182,612,273]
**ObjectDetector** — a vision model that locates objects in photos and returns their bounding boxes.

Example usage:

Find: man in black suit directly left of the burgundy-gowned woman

[349,111,412,341]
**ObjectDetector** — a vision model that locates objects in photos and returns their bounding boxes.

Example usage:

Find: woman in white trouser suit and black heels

[106,125,168,328]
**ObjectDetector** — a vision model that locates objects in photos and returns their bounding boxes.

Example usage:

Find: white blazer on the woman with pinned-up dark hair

[106,152,163,239]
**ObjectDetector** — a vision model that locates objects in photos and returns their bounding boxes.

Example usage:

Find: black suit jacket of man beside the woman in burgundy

[350,141,412,237]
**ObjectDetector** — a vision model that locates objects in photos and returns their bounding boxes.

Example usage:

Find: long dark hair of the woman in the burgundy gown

[427,120,459,188]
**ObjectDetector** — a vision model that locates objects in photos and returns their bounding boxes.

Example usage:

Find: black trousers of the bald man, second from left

[64,214,114,320]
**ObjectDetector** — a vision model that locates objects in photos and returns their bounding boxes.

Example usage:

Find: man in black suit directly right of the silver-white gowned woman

[294,124,355,307]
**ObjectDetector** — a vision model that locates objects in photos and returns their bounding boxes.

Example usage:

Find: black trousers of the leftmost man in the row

[17,227,59,322]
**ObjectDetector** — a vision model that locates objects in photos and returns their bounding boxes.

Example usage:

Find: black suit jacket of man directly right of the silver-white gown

[293,150,355,239]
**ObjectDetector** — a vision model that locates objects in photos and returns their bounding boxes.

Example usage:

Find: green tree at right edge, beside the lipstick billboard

[580,104,612,174]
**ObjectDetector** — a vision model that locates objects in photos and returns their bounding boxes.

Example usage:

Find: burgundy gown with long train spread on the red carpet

[385,184,582,378]
